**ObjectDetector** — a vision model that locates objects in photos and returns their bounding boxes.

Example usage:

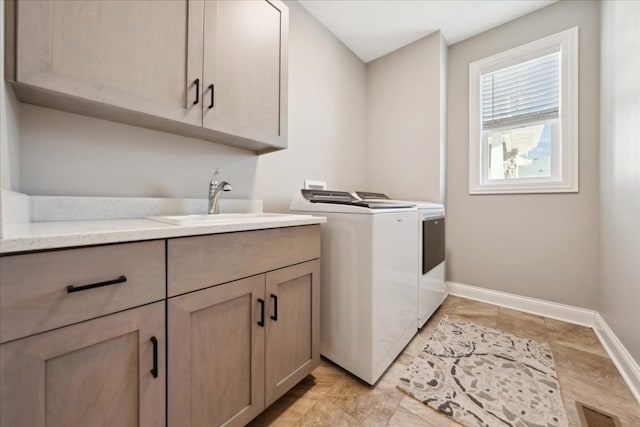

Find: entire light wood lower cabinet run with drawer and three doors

[0,224,320,427]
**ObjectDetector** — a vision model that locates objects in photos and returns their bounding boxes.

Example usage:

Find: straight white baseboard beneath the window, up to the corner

[447,282,597,328]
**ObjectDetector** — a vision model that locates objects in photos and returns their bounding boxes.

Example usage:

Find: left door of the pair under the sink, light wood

[167,275,266,427]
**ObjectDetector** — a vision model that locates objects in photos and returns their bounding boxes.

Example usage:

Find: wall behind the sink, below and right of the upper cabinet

[19,2,366,211]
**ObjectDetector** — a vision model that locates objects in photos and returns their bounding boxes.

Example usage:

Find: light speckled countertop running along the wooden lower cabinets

[0,214,326,254]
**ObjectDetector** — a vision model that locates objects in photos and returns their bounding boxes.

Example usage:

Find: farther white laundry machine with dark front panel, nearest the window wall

[356,191,446,329]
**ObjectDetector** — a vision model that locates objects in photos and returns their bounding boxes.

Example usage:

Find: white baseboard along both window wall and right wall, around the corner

[447,282,640,403]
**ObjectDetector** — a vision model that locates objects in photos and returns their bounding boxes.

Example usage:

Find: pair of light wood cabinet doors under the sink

[167,260,320,427]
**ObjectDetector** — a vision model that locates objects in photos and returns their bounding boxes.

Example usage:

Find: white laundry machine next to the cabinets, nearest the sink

[290,190,419,384]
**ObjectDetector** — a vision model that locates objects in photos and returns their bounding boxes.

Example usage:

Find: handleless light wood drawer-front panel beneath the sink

[167,225,320,297]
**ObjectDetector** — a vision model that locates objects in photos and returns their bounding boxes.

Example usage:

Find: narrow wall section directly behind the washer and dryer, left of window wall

[367,31,446,202]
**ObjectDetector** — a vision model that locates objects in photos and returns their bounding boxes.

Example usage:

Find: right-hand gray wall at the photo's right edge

[598,2,640,364]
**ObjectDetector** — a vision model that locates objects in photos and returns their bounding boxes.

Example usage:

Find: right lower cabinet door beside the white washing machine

[266,260,320,406]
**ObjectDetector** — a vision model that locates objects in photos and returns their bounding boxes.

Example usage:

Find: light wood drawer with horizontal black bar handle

[0,241,165,342]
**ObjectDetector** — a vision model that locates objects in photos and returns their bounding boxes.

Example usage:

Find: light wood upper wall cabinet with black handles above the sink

[6,0,289,153]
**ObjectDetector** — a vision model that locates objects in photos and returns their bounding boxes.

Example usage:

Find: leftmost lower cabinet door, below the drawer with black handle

[0,302,165,427]
